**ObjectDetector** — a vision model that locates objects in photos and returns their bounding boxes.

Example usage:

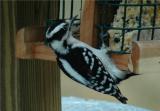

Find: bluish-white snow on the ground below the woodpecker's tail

[62,97,151,111]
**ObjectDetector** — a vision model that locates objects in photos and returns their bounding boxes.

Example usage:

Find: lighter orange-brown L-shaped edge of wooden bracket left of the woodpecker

[15,28,56,61]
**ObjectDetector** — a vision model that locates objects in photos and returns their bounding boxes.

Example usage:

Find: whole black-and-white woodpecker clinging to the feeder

[44,16,137,104]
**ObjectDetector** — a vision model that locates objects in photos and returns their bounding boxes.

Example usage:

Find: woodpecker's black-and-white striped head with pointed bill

[45,16,77,46]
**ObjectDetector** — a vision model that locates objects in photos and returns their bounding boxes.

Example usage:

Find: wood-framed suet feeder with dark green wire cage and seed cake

[81,0,160,73]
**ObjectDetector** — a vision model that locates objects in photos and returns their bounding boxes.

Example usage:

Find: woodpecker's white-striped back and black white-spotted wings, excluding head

[57,47,127,103]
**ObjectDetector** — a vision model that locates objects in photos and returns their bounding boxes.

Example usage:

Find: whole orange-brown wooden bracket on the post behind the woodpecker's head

[16,27,56,61]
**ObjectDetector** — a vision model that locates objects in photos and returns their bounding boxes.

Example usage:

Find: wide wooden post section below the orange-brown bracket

[18,59,61,111]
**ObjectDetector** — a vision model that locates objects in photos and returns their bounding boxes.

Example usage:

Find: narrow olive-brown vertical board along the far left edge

[0,1,16,111]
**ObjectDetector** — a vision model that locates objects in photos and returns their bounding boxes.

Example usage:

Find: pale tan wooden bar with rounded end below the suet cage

[131,40,160,73]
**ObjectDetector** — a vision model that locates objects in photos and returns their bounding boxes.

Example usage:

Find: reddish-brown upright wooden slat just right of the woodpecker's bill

[80,0,97,46]
